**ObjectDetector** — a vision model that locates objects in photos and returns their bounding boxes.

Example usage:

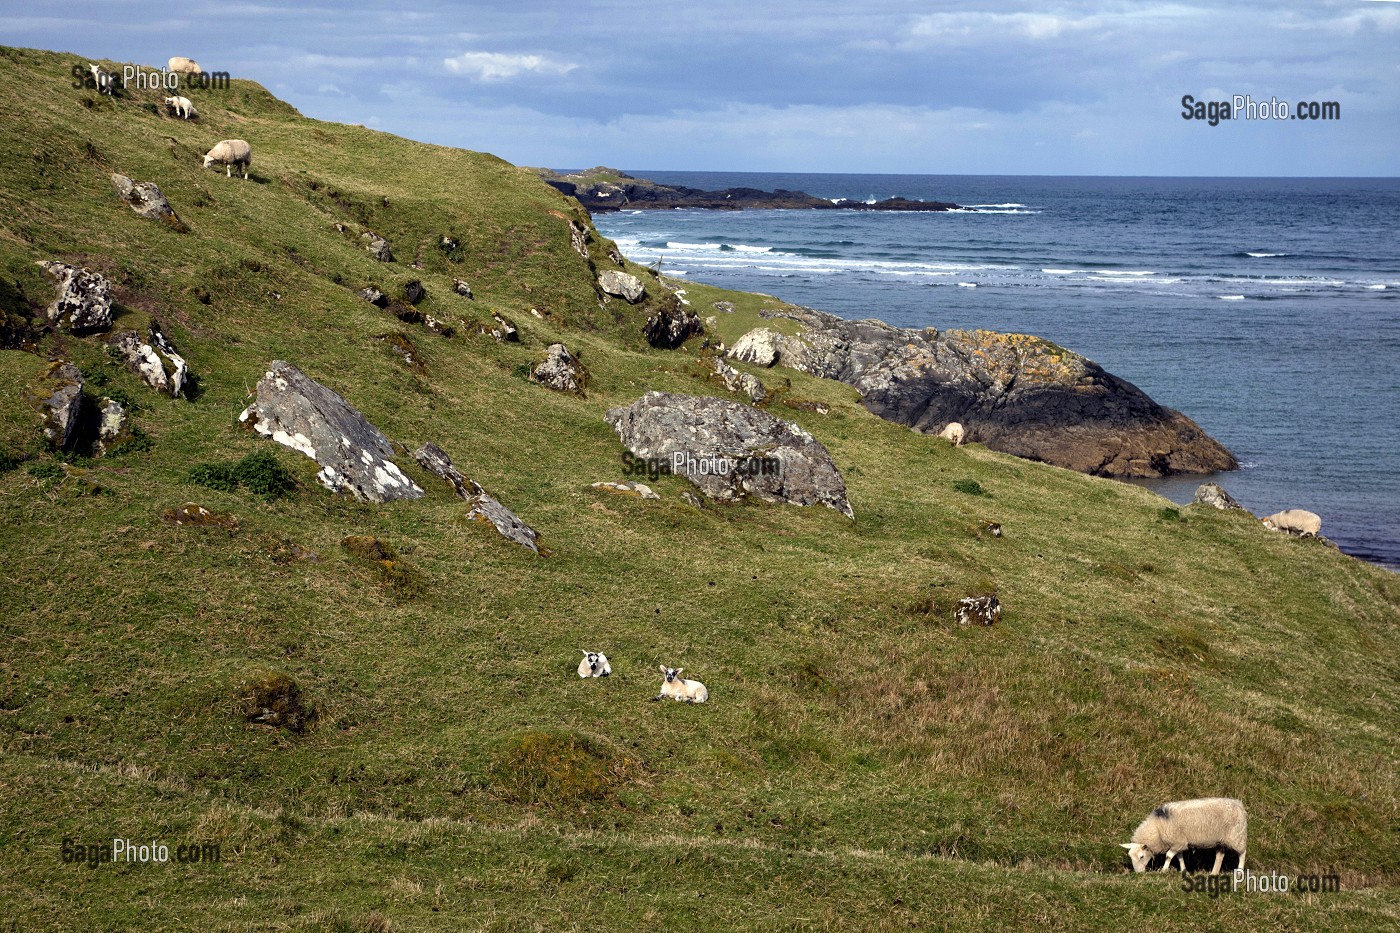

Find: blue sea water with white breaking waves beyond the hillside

[594,171,1400,567]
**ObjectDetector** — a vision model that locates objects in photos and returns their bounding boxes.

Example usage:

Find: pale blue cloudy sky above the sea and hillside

[0,0,1400,177]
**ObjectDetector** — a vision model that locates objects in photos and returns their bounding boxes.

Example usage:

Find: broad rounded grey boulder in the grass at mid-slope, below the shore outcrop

[606,392,855,518]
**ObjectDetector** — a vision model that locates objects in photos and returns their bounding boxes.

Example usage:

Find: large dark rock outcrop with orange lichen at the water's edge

[770,308,1239,476]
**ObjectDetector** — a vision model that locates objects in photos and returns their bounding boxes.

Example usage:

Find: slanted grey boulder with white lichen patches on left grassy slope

[238,360,423,502]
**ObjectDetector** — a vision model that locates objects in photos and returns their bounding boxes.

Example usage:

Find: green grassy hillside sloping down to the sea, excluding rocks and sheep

[0,49,1400,930]
